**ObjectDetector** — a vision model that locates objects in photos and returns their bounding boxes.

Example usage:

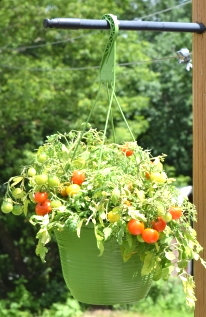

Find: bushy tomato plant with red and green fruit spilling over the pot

[1,125,203,302]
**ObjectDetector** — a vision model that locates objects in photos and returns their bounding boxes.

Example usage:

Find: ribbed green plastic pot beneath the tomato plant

[55,226,152,305]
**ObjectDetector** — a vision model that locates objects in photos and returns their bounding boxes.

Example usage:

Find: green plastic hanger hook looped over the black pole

[99,14,119,87]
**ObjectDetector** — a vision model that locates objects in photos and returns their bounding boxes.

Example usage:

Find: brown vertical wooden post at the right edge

[192,0,206,317]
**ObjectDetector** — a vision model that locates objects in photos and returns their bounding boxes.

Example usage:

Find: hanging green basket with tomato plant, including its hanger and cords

[1,15,205,306]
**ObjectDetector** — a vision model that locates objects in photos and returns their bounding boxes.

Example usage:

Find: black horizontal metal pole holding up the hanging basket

[43,18,206,33]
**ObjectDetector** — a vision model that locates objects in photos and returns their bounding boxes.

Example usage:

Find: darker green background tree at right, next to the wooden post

[138,0,192,178]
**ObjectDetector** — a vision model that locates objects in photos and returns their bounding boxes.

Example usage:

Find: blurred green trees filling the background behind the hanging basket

[0,0,192,311]
